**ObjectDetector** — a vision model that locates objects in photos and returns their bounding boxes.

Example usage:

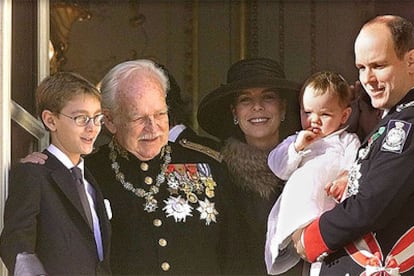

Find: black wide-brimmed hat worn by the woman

[197,58,300,139]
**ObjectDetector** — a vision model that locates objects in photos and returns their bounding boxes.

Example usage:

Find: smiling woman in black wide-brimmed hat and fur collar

[197,58,300,275]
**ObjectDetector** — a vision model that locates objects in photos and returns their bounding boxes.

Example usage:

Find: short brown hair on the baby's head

[299,71,353,108]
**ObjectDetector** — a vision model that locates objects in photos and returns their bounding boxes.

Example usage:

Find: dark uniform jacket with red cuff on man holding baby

[304,90,414,275]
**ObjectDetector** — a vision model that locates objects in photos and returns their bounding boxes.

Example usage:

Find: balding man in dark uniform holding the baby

[292,15,414,275]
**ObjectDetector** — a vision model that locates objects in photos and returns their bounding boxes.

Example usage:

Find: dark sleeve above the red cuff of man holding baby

[320,119,414,249]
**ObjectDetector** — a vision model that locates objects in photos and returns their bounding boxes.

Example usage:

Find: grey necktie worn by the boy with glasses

[72,167,103,261]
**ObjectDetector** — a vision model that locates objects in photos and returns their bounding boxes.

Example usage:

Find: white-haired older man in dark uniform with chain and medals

[86,59,242,275]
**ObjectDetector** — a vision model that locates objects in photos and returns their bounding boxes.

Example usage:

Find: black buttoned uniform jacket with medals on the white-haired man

[87,143,243,275]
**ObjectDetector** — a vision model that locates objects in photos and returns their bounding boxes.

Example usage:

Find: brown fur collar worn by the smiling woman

[222,138,283,199]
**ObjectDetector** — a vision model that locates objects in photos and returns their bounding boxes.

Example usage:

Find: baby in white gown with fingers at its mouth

[265,72,360,274]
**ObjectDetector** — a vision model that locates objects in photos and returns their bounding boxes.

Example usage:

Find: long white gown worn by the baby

[265,129,360,274]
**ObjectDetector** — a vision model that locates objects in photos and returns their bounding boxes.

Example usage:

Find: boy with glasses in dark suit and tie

[0,72,110,275]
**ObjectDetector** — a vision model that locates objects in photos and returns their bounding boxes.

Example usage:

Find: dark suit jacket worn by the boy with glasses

[0,151,111,275]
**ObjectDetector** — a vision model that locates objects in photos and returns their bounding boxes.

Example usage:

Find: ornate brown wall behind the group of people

[62,0,413,133]
